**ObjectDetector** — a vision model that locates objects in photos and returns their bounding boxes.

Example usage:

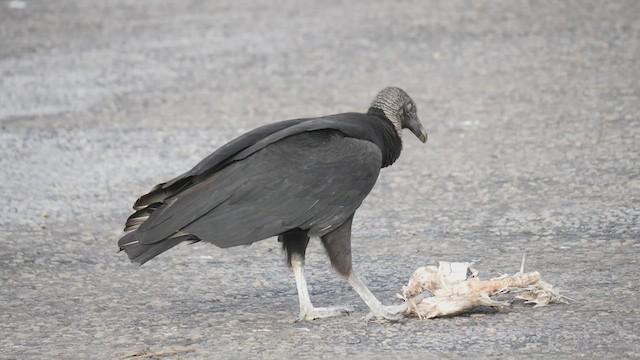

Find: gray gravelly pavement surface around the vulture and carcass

[0,0,640,359]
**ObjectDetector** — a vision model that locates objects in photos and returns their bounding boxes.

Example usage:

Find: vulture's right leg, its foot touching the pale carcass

[322,215,404,320]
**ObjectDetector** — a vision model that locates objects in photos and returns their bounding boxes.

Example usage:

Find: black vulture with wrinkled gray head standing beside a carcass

[118,87,427,320]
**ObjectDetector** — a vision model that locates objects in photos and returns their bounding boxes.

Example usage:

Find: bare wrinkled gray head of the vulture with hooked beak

[371,87,427,142]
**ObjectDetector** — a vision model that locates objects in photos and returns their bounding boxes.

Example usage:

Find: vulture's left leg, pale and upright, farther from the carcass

[279,231,353,320]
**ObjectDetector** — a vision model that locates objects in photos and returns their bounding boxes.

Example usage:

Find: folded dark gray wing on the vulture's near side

[130,129,382,247]
